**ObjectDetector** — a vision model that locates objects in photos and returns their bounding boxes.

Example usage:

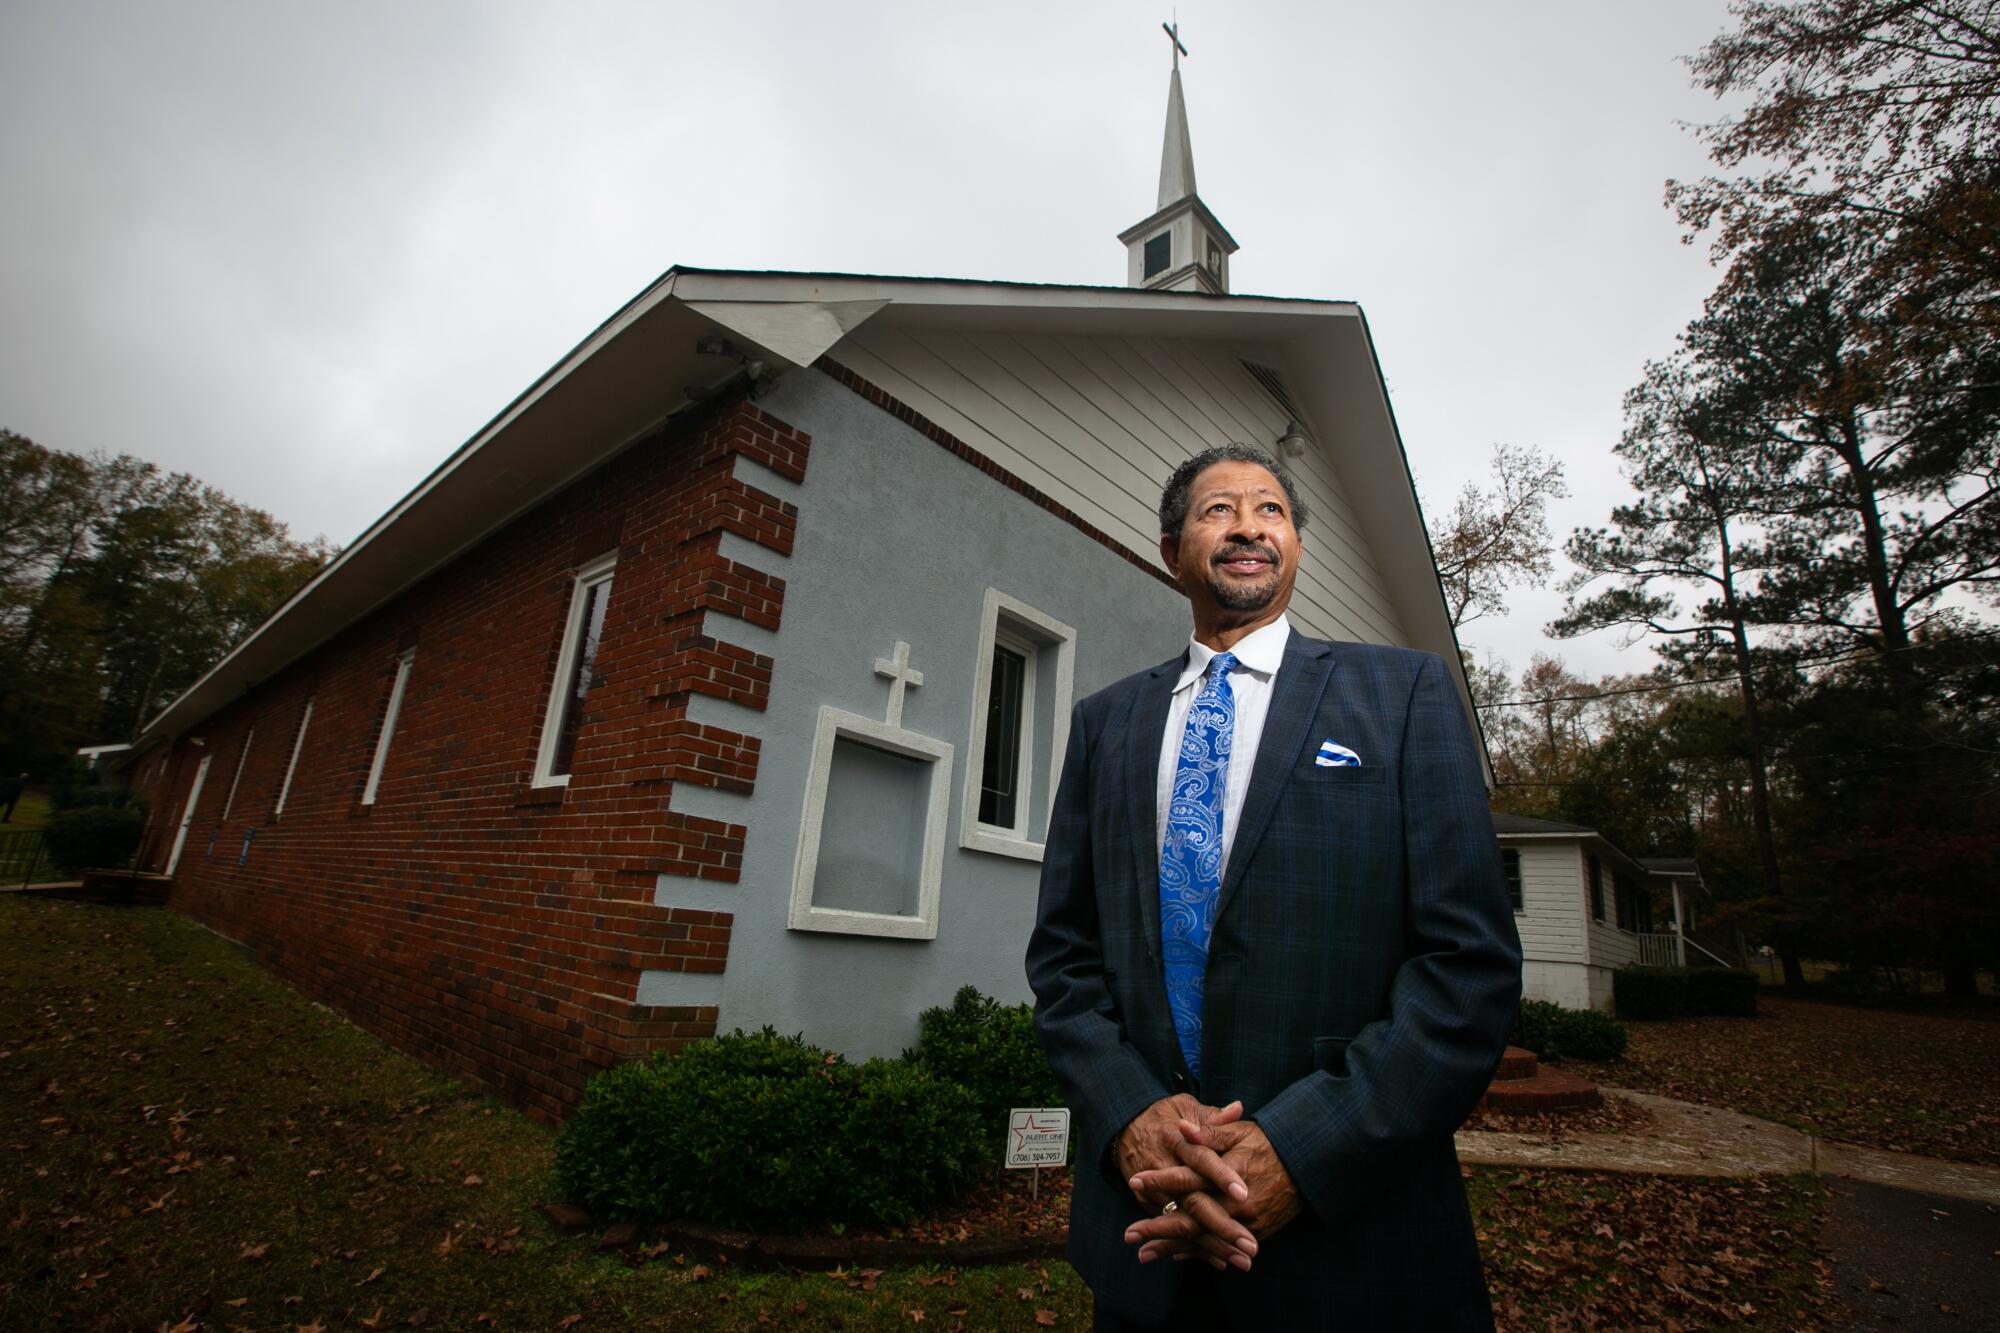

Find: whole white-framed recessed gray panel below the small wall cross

[788,707,952,939]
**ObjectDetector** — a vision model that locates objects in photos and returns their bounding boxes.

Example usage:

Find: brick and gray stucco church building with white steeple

[121,54,1470,1119]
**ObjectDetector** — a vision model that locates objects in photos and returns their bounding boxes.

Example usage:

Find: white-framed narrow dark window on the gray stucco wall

[958,588,1076,861]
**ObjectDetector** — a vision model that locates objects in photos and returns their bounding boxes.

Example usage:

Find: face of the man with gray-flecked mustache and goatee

[1160,462,1298,626]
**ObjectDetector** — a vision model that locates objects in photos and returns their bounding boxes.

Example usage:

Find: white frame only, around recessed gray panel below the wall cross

[788,705,952,939]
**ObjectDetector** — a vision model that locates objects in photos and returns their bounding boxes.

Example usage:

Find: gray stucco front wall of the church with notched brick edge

[640,370,1188,1057]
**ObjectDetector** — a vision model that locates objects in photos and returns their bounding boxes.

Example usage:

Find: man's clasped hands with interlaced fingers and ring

[1114,1093,1300,1271]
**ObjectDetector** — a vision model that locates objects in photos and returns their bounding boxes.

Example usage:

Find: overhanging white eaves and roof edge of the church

[136,268,1476,749]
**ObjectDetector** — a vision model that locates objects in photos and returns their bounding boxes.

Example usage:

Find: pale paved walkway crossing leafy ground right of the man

[1458,1087,2000,1205]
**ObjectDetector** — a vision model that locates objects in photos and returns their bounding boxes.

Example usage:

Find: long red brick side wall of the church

[140,402,810,1119]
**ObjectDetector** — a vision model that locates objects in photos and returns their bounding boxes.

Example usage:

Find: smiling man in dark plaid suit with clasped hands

[1028,444,1520,1331]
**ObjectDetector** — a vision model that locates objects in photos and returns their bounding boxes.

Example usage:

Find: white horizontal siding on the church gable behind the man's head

[832,324,1408,644]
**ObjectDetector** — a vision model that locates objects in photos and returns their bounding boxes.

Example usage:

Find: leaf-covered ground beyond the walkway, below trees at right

[1564,993,2000,1163]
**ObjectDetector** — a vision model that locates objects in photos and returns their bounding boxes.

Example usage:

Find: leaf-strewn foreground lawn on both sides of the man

[0,895,1820,1333]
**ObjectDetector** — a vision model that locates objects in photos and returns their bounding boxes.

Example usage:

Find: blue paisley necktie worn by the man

[1160,652,1236,1079]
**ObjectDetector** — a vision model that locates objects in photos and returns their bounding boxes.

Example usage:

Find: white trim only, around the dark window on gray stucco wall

[958,588,1076,861]
